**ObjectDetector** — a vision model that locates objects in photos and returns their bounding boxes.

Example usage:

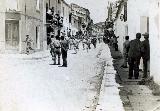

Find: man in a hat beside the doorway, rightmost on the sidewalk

[141,33,150,78]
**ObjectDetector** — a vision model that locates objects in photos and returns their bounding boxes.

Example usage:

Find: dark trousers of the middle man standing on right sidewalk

[128,58,140,79]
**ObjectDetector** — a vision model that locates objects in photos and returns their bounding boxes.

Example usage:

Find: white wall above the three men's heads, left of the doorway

[127,0,150,39]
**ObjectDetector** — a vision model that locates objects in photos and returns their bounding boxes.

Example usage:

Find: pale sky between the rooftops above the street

[65,0,112,23]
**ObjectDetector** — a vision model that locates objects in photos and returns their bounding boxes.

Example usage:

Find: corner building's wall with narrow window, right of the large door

[19,0,45,52]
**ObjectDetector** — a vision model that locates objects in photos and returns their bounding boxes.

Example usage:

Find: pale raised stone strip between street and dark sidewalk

[96,44,124,111]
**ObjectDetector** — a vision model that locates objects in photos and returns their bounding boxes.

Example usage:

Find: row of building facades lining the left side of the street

[0,0,90,53]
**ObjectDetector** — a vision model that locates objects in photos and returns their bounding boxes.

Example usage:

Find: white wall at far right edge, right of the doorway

[149,0,160,84]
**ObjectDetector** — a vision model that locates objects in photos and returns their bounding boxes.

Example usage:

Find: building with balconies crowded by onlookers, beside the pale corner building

[44,0,63,37]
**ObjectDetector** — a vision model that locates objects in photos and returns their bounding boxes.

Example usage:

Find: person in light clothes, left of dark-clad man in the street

[51,36,61,65]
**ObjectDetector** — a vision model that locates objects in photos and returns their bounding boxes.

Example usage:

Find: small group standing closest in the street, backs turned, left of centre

[49,35,69,67]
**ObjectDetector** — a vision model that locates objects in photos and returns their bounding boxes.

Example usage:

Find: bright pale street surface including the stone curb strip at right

[0,43,123,111]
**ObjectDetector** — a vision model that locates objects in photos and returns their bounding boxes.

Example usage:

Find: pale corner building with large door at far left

[0,0,44,53]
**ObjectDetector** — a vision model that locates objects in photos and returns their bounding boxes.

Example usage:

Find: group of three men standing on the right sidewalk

[122,33,150,79]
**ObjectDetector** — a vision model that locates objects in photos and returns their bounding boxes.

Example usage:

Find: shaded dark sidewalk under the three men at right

[110,47,160,111]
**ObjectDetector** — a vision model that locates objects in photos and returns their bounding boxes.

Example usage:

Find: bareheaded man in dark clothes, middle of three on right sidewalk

[128,33,141,79]
